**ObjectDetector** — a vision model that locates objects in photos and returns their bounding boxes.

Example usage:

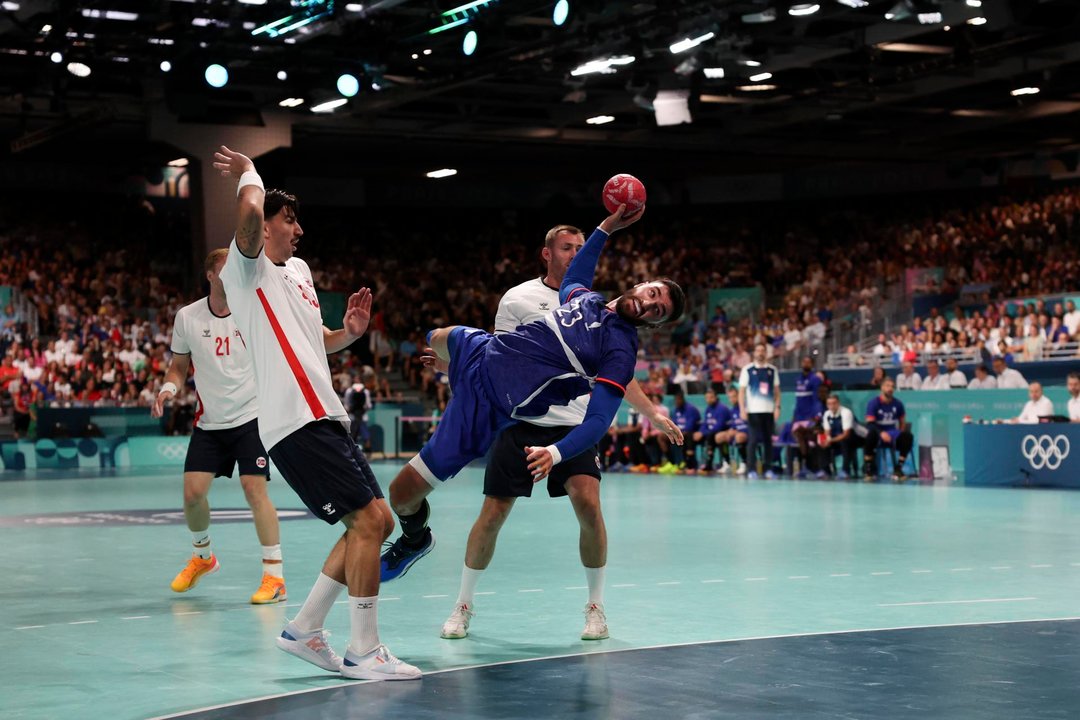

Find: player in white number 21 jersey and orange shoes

[150,248,285,604]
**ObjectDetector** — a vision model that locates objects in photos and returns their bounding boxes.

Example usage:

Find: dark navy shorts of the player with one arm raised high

[270,420,382,525]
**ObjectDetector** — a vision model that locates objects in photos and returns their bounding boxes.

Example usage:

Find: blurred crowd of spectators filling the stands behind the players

[0,180,1080,440]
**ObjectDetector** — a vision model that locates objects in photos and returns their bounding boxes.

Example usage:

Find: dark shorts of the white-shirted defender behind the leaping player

[484,422,600,498]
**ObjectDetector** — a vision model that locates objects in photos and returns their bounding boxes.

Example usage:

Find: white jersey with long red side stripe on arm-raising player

[221,245,349,450]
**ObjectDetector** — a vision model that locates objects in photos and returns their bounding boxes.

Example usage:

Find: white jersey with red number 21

[172,298,259,430]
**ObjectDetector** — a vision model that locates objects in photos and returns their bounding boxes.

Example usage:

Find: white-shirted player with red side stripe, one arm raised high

[214,147,420,680]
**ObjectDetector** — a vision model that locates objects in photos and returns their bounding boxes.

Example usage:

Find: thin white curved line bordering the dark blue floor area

[148,616,1080,720]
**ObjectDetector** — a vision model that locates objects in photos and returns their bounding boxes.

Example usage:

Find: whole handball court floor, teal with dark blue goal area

[0,463,1080,720]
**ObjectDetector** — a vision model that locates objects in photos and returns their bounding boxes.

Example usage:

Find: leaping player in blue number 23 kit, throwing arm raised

[381,206,686,582]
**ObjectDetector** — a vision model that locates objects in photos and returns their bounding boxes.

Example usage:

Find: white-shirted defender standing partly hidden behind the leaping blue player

[440,225,683,640]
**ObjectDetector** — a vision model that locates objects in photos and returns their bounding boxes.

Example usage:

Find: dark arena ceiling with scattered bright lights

[0,0,1080,172]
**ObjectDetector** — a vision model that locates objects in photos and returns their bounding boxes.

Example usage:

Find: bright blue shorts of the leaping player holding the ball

[409,326,513,487]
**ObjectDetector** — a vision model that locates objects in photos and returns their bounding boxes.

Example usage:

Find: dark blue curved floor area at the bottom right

[164,621,1080,720]
